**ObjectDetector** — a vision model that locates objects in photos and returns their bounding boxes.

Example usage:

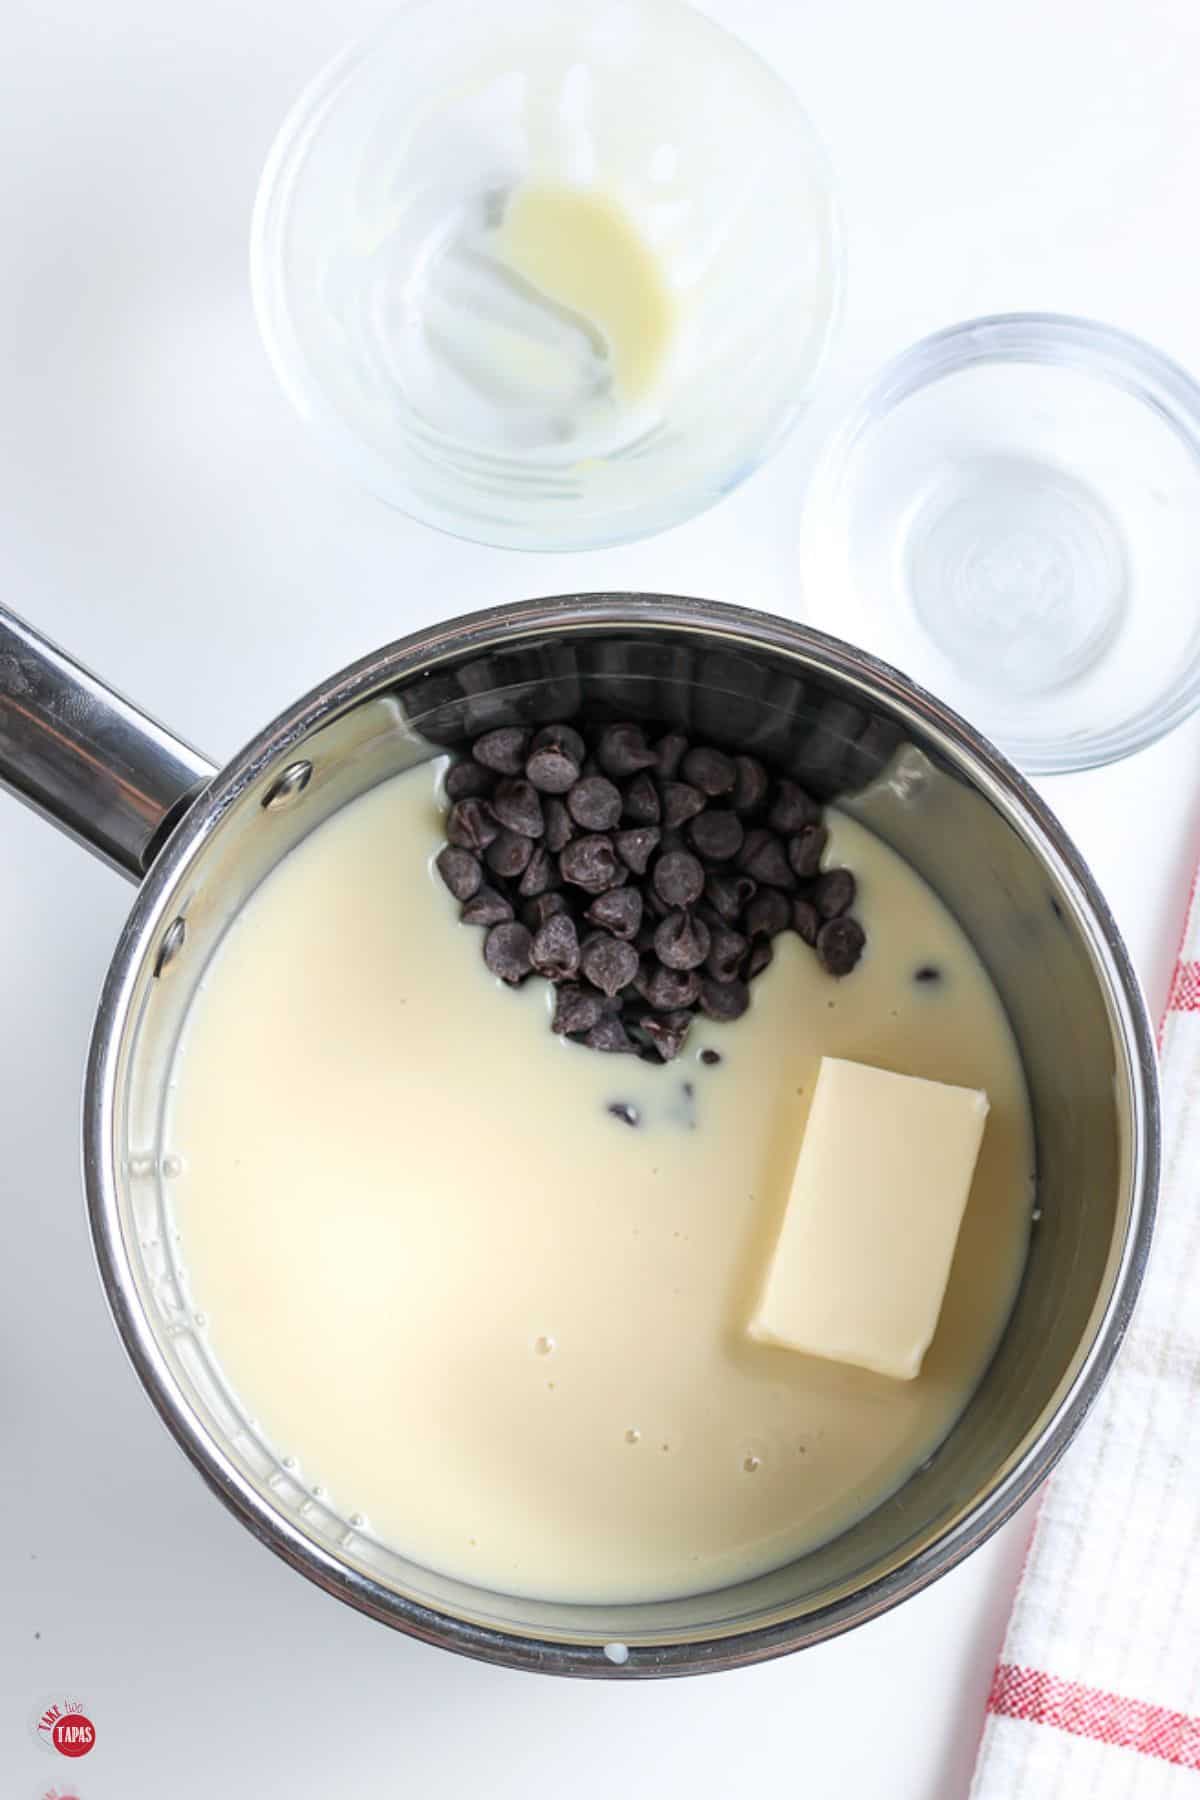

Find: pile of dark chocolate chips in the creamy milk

[437,724,865,1062]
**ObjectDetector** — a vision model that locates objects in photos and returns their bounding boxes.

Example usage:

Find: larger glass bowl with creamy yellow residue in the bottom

[252,0,842,551]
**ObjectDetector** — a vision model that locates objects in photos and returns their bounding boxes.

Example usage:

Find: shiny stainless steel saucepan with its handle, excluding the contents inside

[0,594,1159,1679]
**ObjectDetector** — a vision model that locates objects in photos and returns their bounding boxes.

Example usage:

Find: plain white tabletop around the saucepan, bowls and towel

[0,0,1200,1800]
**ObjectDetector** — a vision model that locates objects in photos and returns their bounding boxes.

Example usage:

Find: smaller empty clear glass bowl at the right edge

[801,313,1200,774]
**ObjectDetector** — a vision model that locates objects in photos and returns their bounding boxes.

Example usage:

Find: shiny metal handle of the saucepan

[0,607,216,882]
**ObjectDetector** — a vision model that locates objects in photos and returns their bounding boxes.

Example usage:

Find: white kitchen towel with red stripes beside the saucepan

[972,914,1200,1800]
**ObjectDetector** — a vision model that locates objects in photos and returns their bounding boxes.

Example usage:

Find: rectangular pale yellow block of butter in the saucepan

[750,1057,988,1381]
